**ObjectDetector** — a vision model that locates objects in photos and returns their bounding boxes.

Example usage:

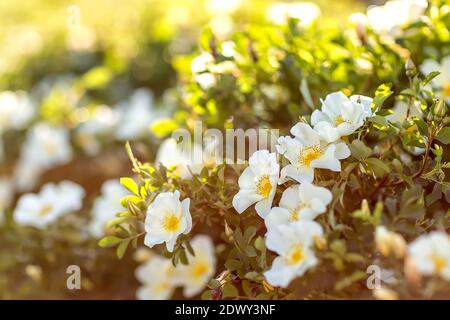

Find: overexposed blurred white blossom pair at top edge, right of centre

[266,2,320,27]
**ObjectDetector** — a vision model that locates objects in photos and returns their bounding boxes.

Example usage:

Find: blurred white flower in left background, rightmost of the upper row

[115,89,163,141]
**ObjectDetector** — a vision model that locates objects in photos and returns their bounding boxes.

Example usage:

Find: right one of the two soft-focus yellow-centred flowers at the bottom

[176,235,216,298]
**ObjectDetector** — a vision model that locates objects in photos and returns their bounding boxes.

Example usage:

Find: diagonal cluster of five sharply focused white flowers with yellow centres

[233,92,372,287]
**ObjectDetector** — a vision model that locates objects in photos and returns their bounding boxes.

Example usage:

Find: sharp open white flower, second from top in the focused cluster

[277,123,350,183]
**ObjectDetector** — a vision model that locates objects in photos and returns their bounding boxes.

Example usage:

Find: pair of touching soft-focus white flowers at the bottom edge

[136,235,216,300]
